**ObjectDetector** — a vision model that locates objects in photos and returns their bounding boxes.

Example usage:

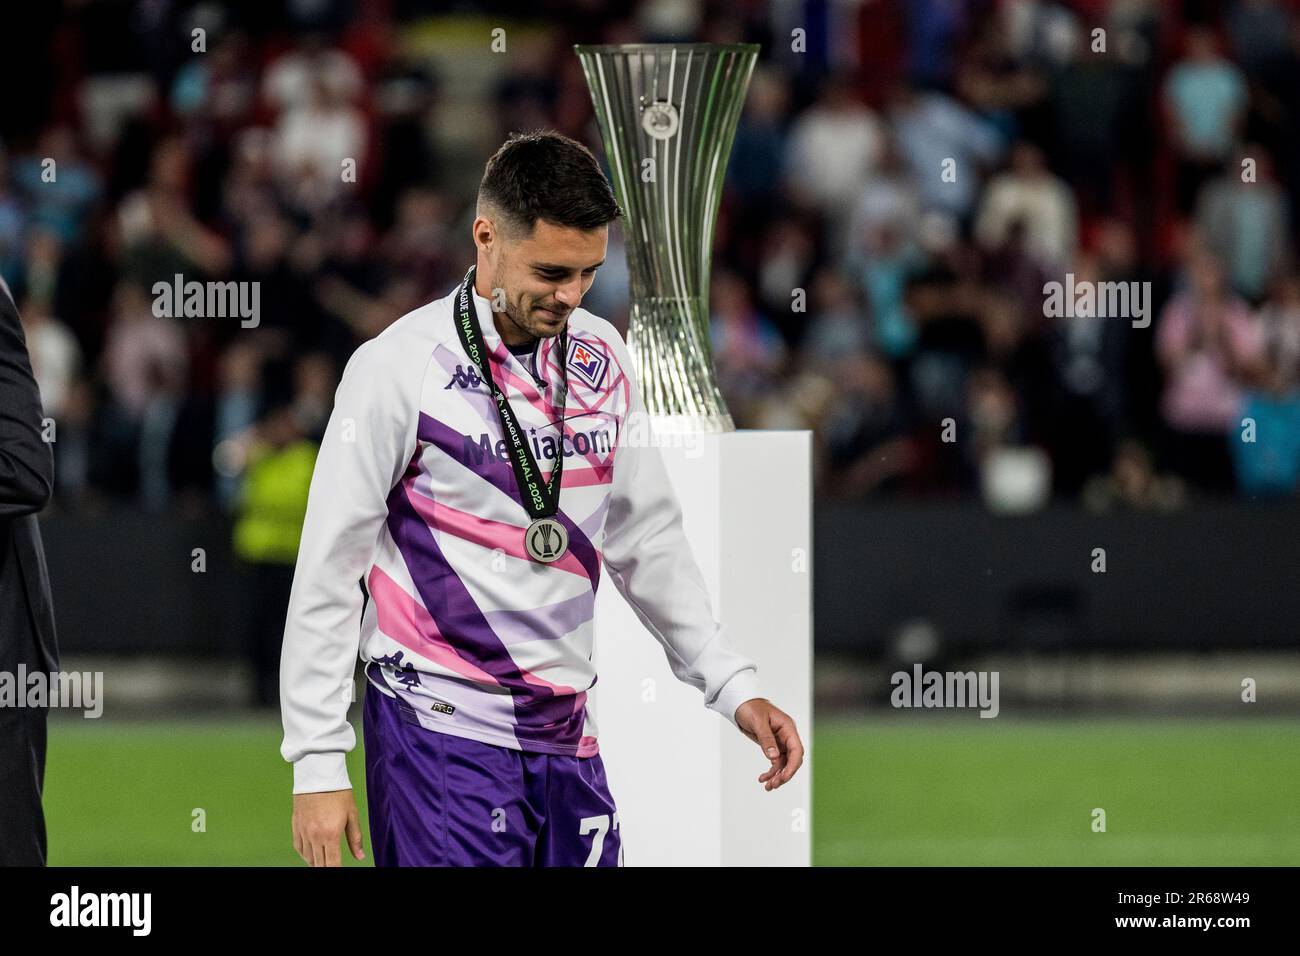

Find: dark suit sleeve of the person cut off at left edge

[0,282,55,519]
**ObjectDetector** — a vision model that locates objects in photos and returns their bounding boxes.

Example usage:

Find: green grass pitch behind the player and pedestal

[46,715,1300,866]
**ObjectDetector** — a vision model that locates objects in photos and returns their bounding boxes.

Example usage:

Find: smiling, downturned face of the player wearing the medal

[475,220,610,341]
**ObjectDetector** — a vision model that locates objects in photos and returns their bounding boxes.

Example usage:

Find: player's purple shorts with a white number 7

[361,684,623,866]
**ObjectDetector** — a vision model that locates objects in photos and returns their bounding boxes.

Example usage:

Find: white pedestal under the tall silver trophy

[593,431,813,866]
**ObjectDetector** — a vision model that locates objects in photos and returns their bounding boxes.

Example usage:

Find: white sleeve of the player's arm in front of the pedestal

[603,341,762,724]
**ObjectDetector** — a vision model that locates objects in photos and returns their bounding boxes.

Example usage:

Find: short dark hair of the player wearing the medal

[478,130,621,239]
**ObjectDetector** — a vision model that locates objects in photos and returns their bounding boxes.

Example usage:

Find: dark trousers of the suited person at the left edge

[0,635,47,866]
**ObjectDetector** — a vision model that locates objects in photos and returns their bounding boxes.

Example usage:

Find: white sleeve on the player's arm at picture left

[280,339,423,793]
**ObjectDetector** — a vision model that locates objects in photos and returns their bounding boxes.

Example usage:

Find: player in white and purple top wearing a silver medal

[281,133,803,866]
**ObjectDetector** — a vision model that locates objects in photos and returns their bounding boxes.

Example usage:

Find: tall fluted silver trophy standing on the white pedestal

[573,43,759,432]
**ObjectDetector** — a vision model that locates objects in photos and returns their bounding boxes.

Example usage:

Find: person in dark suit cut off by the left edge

[0,280,59,866]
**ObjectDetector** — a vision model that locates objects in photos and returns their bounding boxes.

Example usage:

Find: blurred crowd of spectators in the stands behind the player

[0,0,1300,530]
